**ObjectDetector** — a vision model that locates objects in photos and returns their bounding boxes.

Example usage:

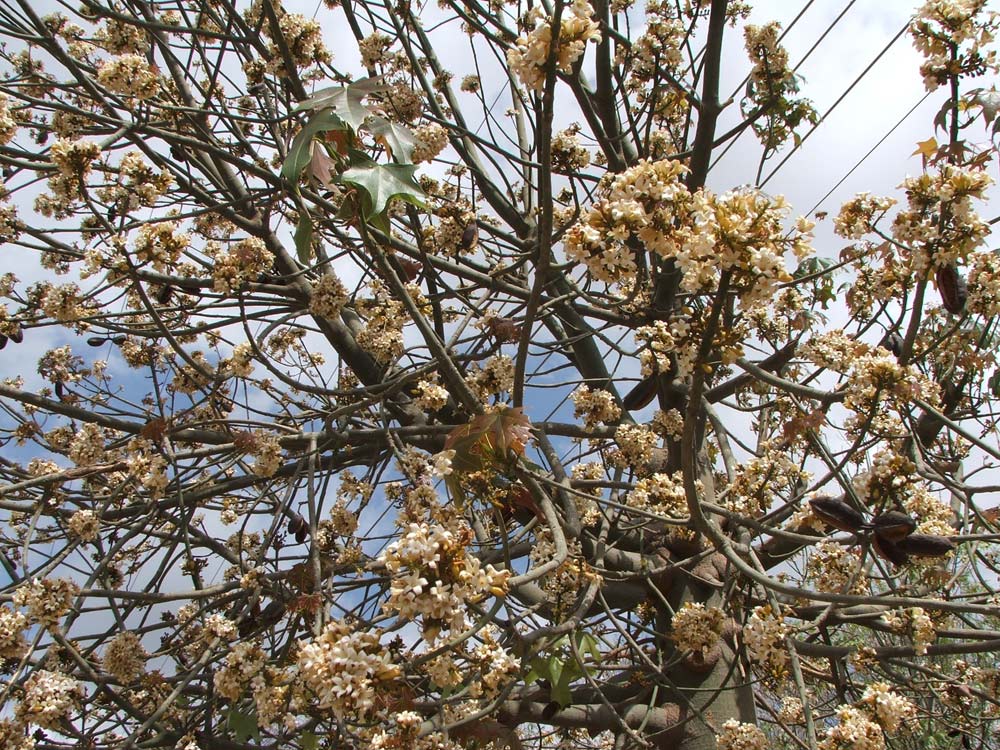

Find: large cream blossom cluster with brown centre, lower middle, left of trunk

[378,518,510,641]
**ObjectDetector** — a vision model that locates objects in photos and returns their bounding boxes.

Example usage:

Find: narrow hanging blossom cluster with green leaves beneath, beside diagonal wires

[743,22,818,150]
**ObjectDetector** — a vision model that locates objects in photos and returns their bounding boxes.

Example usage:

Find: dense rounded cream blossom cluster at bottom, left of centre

[297,620,402,719]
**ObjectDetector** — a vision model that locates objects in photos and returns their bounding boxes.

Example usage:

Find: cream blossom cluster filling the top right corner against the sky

[910,0,1000,91]
